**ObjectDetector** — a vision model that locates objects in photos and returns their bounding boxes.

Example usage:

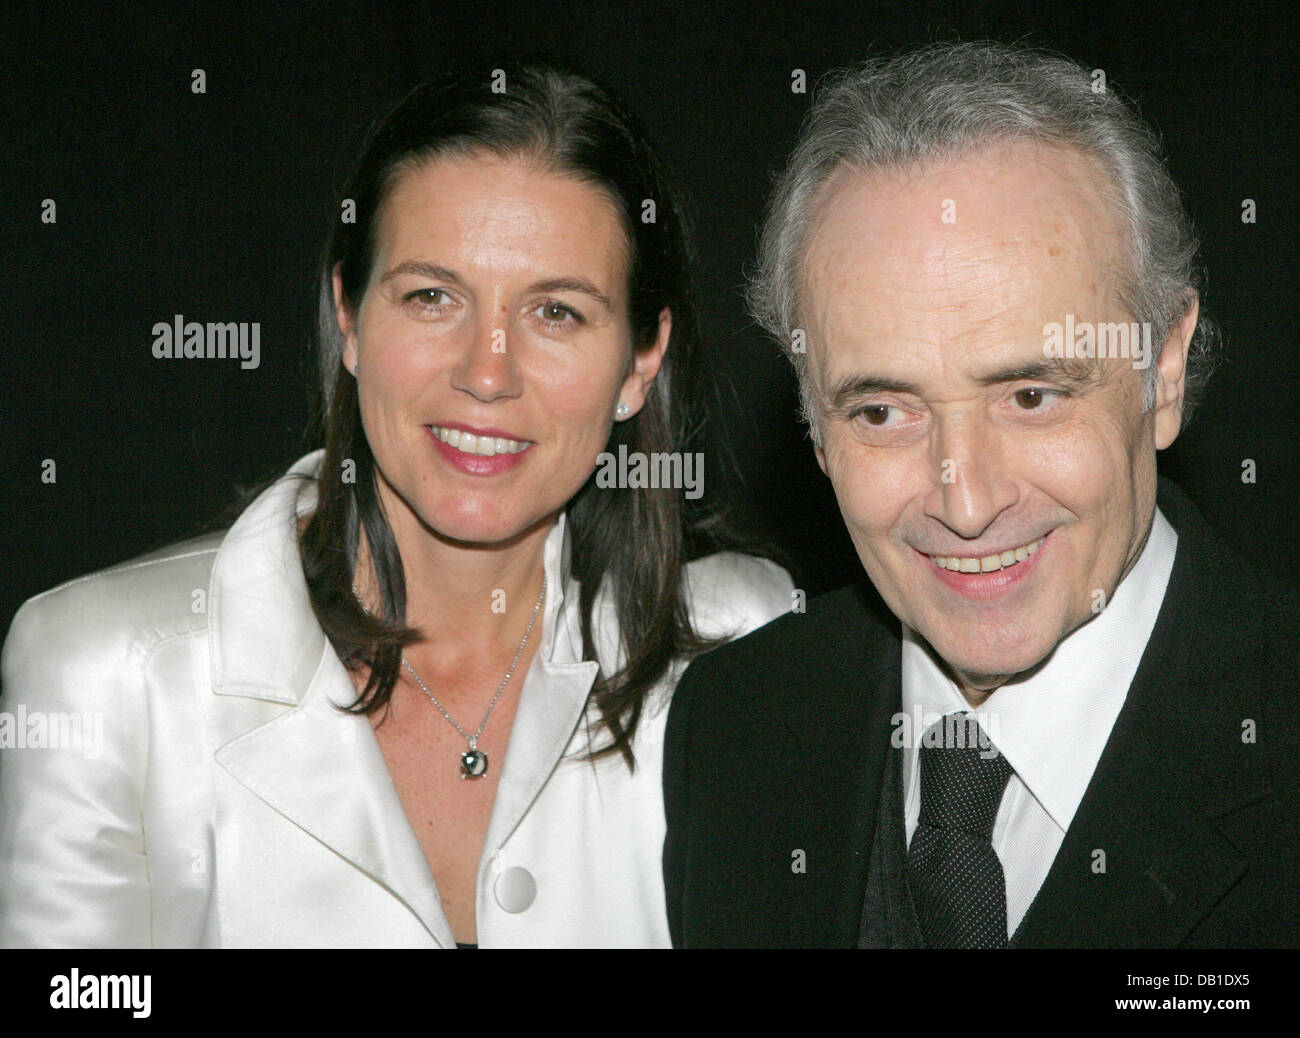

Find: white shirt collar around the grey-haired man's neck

[902,509,1178,831]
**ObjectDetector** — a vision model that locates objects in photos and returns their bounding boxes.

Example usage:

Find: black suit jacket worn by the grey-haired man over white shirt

[664,480,1300,947]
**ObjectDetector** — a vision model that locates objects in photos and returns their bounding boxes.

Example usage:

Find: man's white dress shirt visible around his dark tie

[902,509,1178,937]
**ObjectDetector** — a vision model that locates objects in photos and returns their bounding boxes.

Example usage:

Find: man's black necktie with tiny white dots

[907,714,1011,948]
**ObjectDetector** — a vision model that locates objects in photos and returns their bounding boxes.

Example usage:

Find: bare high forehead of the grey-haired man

[802,143,1122,379]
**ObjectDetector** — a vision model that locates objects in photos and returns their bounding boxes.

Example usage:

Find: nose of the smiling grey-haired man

[926,416,1018,540]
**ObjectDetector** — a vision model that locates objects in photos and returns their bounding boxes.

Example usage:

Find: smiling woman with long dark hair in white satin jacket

[0,66,792,947]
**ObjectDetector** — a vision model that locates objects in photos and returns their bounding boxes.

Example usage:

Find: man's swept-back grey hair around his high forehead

[749,43,1219,444]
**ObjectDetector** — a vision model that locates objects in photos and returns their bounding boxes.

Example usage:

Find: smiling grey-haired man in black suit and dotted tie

[664,44,1300,947]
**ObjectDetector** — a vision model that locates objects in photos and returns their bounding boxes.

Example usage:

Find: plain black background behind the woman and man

[0,3,1300,642]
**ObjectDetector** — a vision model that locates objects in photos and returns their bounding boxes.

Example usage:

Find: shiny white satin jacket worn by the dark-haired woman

[0,453,792,948]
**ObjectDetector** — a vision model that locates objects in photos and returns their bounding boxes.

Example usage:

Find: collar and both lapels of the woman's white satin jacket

[208,451,599,946]
